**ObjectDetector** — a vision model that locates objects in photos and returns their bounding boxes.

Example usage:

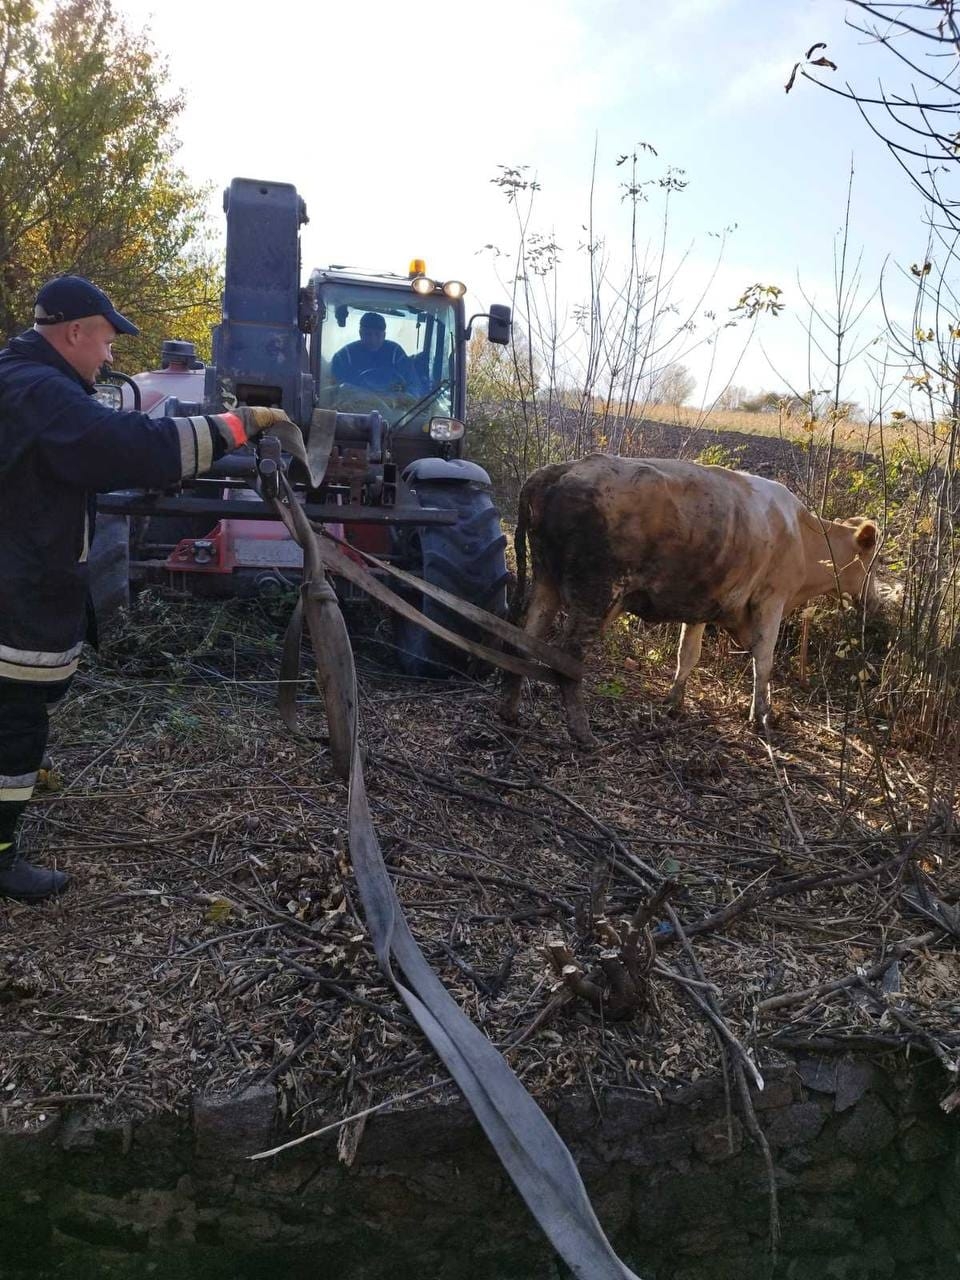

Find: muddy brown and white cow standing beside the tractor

[500,454,877,745]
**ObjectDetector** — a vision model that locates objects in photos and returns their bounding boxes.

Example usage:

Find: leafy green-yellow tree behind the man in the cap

[0,0,220,369]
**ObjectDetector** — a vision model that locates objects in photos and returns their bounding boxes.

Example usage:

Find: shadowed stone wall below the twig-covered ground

[0,1059,960,1280]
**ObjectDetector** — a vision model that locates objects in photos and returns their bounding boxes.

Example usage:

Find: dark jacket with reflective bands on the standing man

[0,329,235,682]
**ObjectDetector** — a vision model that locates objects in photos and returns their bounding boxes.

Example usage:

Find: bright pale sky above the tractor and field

[115,0,942,409]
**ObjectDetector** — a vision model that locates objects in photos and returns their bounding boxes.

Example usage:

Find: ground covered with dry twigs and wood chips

[0,576,960,1128]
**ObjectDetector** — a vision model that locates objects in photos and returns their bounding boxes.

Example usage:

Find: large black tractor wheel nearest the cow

[393,481,509,680]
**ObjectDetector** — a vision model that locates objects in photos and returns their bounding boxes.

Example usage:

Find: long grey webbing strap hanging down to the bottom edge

[267,477,637,1280]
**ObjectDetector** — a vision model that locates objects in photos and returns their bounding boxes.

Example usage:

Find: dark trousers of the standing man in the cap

[0,680,70,859]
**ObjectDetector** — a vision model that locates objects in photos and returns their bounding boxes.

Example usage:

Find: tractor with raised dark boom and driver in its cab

[91,178,511,676]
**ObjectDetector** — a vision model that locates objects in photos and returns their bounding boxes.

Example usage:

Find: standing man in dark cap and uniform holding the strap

[0,275,288,901]
